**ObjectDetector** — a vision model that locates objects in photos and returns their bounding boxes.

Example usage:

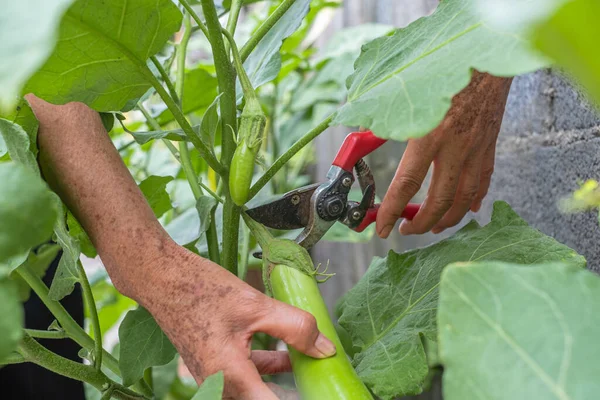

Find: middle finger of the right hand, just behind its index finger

[400,152,462,235]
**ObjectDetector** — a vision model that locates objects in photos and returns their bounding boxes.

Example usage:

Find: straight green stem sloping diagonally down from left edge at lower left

[15,265,152,397]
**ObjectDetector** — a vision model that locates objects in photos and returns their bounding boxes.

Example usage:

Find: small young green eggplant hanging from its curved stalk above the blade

[223,29,267,206]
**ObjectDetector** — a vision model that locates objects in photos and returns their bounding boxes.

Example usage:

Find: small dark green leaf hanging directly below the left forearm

[119,307,176,386]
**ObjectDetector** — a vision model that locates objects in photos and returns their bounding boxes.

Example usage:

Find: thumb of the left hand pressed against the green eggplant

[254,299,336,358]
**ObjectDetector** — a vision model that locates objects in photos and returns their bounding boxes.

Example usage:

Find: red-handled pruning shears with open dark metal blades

[246,131,420,250]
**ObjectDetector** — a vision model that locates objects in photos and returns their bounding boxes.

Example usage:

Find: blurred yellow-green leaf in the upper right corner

[534,0,600,105]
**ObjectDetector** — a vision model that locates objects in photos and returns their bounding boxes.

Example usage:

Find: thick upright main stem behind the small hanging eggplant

[200,0,240,275]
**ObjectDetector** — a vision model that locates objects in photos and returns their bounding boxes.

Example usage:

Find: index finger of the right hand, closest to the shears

[377,140,435,238]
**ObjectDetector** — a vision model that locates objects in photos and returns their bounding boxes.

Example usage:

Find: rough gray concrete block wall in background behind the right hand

[313,0,600,400]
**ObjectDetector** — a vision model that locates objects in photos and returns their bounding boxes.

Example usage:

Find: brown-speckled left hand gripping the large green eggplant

[132,244,335,400]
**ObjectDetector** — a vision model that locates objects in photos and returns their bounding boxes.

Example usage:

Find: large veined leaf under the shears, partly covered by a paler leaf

[338,202,585,399]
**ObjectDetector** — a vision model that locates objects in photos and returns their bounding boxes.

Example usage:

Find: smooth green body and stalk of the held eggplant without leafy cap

[243,213,373,400]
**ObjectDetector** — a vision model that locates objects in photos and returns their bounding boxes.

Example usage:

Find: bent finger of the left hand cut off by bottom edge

[225,359,277,400]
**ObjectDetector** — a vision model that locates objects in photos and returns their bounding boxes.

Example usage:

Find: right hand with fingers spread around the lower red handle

[377,71,512,238]
